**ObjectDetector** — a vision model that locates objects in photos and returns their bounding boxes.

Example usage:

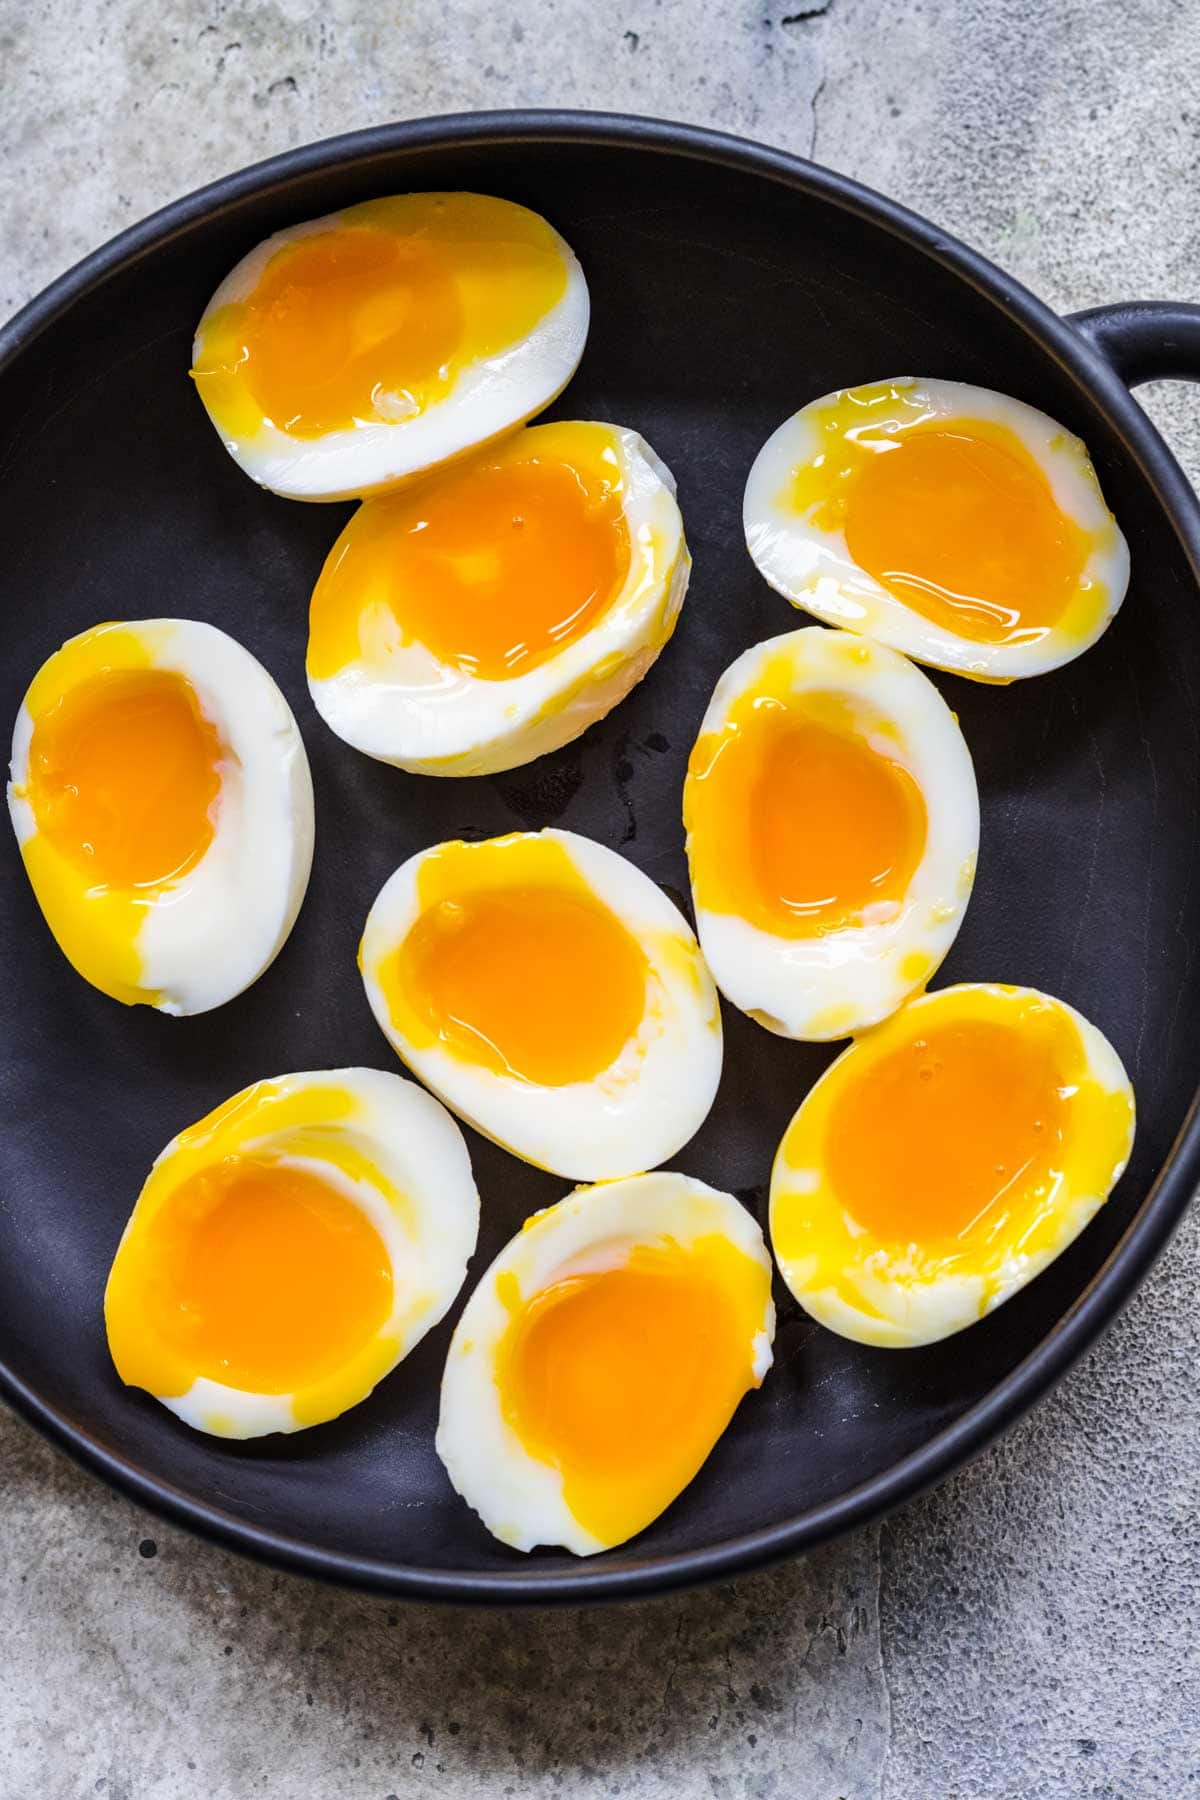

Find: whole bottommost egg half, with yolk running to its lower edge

[437,1172,775,1555]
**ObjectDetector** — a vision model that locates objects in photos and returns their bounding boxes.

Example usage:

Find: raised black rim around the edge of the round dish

[0,108,1200,1606]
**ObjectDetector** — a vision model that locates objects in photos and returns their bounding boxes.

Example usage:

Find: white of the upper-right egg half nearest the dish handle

[743,376,1130,682]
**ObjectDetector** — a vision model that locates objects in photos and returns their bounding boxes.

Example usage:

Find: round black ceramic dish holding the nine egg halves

[0,115,1200,1600]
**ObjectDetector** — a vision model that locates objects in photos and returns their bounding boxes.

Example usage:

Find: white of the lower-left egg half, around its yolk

[103,1069,479,1438]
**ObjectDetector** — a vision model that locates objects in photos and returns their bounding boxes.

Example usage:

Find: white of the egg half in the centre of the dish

[360,830,721,1181]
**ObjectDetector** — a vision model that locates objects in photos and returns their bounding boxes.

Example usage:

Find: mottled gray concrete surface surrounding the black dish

[0,0,1200,1800]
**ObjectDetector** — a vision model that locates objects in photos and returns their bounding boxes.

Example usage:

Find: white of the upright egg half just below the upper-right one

[689,626,979,1042]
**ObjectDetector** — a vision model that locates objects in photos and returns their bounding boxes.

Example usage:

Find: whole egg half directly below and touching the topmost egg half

[308,421,691,776]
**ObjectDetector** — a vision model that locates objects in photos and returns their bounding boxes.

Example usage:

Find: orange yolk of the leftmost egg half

[27,668,223,887]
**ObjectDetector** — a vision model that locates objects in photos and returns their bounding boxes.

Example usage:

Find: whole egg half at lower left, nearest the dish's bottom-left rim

[104,1069,479,1438]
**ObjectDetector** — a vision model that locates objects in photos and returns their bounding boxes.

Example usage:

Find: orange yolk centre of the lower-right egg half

[824,1017,1067,1244]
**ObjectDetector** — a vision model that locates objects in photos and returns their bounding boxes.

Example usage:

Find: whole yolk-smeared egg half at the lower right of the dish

[770,983,1133,1348]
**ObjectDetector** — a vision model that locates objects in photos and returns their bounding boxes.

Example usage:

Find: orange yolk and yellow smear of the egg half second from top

[308,425,630,680]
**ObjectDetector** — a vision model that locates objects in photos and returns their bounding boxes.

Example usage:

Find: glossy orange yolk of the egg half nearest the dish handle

[846,425,1087,644]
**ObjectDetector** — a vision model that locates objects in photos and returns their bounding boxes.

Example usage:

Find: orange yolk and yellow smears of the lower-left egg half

[104,1082,417,1435]
